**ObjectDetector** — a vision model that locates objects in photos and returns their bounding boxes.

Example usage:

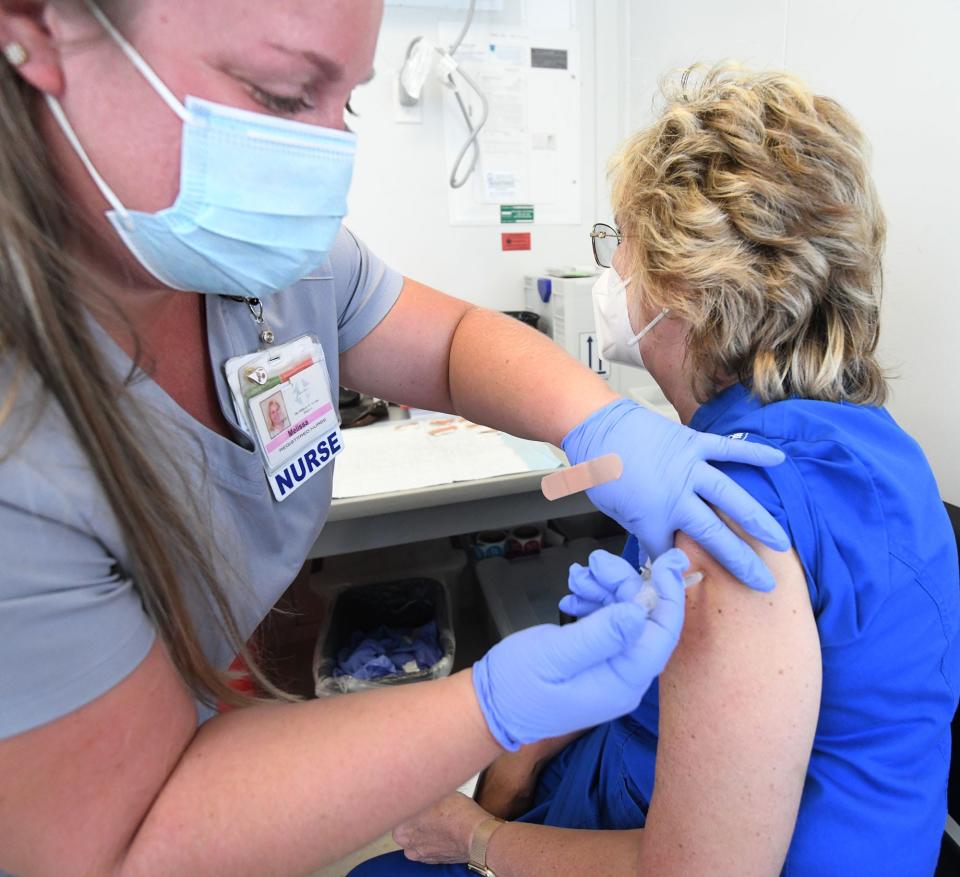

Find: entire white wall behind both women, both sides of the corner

[348,0,960,504]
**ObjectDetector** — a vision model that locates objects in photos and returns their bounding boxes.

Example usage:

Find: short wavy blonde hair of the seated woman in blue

[611,64,886,405]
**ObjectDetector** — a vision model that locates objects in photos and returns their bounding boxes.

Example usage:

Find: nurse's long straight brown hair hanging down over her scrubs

[0,2,292,706]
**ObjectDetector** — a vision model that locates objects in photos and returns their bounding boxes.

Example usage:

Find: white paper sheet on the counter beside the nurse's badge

[333,417,561,499]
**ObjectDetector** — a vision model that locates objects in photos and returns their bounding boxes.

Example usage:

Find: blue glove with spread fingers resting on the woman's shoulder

[563,399,790,591]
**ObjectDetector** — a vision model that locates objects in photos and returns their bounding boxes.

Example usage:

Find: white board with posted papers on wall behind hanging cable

[439,23,581,225]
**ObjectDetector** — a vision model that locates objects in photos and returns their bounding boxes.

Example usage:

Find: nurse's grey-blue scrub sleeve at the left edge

[0,490,155,738]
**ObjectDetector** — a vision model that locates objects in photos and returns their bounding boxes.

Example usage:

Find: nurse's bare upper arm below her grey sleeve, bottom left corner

[0,641,196,877]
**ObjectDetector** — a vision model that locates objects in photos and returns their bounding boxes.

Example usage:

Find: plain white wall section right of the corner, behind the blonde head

[624,0,960,504]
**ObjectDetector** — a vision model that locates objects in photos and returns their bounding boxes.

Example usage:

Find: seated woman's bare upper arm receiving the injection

[642,516,821,877]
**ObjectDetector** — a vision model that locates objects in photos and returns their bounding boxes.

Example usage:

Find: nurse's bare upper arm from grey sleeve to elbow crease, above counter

[340,277,473,411]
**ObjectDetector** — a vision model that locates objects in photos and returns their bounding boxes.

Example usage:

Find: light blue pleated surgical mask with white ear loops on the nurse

[47,0,356,299]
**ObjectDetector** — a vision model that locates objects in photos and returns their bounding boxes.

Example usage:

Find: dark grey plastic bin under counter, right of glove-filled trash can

[477,539,622,638]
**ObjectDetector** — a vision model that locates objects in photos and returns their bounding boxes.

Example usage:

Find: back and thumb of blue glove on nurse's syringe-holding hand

[473,552,687,750]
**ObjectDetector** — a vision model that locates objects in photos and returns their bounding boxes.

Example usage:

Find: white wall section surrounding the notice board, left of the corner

[347,0,623,310]
